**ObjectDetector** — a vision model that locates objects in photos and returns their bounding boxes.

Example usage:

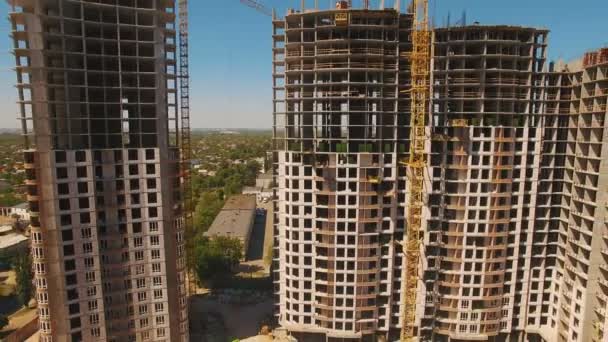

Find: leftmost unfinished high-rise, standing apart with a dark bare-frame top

[10,0,188,342]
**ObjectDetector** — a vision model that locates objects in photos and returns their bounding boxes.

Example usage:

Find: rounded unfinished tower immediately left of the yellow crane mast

[273,9,412,341]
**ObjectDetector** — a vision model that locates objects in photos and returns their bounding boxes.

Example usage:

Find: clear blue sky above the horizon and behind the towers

[0,0,608,128]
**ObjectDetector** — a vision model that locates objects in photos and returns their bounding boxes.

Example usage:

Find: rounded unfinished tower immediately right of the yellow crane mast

[420,26,556,341]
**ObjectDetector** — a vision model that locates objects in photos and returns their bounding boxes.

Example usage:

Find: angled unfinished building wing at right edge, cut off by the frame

[539,48,608,342]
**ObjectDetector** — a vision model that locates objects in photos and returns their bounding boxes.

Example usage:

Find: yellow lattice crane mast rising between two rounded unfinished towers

[400,0,431,341]
